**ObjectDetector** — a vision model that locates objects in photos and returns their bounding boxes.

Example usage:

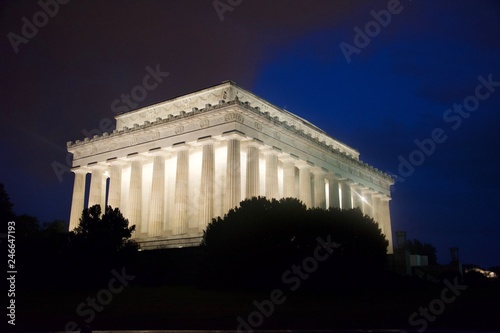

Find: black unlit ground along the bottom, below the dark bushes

[15,278,500,332]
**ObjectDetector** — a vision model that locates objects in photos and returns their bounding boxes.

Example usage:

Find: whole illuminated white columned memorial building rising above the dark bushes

[67,81,394,249]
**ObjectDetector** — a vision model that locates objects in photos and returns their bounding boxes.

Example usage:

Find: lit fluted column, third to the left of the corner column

[148,151,165,237]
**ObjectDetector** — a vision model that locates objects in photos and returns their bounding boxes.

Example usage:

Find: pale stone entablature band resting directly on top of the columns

[68,98,394,190]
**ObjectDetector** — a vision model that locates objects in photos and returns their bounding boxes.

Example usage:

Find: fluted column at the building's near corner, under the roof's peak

[225,138,241,211]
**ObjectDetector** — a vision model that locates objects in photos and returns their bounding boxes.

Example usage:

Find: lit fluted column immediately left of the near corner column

[199,141,215,231]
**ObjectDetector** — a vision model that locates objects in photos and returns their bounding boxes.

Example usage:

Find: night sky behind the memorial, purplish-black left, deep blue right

[0,0,500,267]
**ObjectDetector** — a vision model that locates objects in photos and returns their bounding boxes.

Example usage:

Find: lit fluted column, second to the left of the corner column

[173,145,189,235]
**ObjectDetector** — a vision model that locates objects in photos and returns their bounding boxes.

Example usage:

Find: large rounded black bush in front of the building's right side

[200,197,388,287]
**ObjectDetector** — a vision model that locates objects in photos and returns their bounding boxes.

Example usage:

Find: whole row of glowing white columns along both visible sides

[70,136,390,248]
